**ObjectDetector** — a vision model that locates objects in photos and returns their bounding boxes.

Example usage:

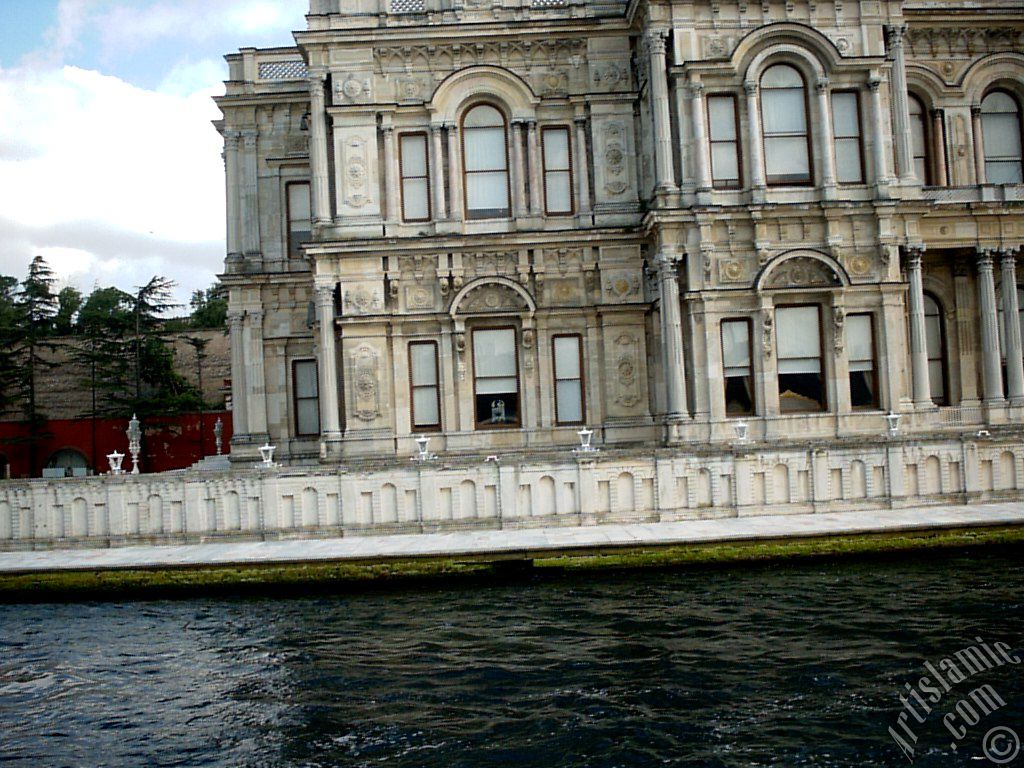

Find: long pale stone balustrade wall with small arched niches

[0,438,1024,550]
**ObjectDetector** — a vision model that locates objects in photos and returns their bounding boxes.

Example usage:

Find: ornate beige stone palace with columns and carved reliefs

[211,0,1024,462]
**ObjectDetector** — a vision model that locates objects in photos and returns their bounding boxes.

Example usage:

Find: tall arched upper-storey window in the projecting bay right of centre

[761,65,811,184]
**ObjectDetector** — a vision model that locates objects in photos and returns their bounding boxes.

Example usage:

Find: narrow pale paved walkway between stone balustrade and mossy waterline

[0,503,1024,573]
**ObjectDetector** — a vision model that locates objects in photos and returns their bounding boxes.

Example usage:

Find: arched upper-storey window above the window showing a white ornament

[462,104,510,219]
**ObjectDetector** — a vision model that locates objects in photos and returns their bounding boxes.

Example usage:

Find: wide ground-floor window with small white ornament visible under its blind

[473,328,519,427]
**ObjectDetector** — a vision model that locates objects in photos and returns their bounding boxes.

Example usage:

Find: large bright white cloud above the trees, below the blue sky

[0,67,224,297]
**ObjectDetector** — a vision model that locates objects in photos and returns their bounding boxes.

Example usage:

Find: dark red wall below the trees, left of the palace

[0,411,231,477]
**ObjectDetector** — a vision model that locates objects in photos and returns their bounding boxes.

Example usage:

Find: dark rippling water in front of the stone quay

[0,550,1024,768]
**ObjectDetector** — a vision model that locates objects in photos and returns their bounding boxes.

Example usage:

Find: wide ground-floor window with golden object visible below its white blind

[775,306,825,414]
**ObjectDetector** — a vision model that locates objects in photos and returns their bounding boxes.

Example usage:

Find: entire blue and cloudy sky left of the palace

[0,0,308,309]
